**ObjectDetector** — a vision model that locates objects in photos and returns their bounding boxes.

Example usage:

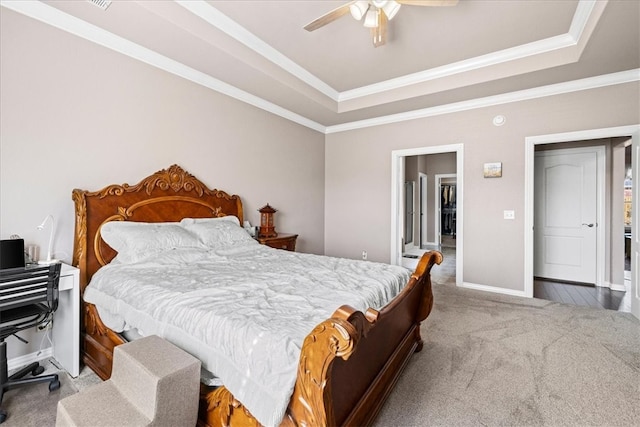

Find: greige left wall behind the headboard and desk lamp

[0,8,324,358]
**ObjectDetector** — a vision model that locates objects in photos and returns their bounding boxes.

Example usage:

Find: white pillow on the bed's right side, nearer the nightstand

[180,216,257,249]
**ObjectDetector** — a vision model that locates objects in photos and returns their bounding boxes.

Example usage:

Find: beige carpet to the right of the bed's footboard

[375,284,640,427]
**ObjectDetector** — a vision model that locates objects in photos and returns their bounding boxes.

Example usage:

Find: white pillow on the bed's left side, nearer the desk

[100,221,202,263]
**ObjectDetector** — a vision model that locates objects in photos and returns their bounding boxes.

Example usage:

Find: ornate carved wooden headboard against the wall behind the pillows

[72,165,243,291]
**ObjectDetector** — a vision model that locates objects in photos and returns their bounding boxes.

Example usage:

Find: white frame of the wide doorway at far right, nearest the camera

[523,124,640,318]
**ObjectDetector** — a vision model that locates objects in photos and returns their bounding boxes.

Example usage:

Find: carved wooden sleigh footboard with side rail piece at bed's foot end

[198,251,442,426]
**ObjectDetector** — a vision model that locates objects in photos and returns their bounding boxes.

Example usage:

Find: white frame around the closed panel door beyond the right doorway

[531,144,606,288]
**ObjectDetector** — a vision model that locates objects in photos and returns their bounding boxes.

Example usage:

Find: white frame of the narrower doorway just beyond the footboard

[390,144,464,286]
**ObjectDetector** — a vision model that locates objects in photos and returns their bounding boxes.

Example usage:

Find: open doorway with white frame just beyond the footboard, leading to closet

[391,144,463,284]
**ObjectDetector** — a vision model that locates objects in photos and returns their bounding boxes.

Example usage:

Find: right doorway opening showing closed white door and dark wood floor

[533,137,631,312]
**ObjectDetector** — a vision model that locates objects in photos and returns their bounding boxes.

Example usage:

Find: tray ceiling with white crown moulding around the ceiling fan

[6,0,640,132]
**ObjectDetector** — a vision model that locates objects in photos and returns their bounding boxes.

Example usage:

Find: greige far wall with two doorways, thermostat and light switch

[325,82,640,291]
